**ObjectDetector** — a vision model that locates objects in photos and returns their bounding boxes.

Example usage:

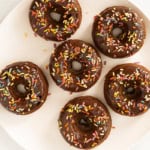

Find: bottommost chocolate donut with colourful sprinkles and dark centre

[58,96,112,149]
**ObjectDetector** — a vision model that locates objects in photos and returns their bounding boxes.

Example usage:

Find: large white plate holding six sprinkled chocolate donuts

[0,0,150,150]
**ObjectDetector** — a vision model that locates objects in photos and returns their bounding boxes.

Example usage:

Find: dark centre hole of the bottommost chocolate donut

[77,114,94,132]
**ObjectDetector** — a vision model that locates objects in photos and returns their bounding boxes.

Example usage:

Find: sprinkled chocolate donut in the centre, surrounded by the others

[49,40,102,92]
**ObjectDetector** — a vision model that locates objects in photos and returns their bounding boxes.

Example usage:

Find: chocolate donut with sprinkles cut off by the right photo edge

[104,63,150,116]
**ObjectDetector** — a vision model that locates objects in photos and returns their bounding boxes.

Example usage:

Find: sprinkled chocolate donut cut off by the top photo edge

[29,0,82,41]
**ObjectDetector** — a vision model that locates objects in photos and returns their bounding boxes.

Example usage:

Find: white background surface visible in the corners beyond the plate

[0,0,150,150]
